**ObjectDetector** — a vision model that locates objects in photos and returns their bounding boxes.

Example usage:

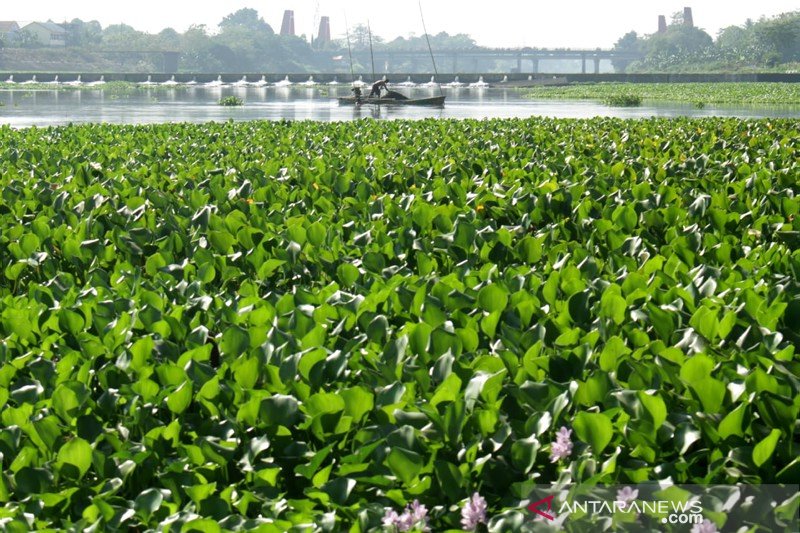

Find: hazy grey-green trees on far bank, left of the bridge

[0,8,476,73]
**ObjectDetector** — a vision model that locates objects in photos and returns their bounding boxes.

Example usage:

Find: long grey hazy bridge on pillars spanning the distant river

[361,48,642,74]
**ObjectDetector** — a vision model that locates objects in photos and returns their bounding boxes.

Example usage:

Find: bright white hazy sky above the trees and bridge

[6,0,800,48]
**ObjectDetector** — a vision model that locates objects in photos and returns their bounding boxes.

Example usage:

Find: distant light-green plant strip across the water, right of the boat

[524,83,800,105]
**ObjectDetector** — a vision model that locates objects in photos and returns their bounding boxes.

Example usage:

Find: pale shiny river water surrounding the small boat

[0,87,800,127]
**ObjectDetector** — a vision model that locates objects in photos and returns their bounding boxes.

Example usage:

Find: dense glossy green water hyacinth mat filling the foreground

[0,119,800,532]
